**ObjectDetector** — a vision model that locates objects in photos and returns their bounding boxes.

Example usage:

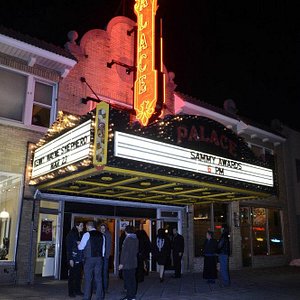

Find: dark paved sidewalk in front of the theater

[0,266,300,300]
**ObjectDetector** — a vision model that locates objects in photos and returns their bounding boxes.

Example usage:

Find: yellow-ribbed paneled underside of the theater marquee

[37,167,268,205]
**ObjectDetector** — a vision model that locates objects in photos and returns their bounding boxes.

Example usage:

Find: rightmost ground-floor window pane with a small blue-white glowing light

[268,209,283,255]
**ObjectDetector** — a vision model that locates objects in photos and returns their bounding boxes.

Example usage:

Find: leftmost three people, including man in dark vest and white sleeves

[66,221,111,300]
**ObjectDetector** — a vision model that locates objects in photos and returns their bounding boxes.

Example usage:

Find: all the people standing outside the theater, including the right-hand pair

[66,221,230,300]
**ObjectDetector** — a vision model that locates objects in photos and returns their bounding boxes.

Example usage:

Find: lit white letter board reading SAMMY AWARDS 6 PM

[114,132,274,187]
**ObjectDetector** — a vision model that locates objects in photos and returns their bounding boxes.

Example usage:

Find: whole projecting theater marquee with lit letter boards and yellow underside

[31,102,275,205]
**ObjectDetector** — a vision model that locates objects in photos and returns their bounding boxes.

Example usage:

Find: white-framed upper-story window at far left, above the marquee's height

[0,68,56,128]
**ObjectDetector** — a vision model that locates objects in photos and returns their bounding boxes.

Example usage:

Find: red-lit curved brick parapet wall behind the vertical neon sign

[58,17,176,115]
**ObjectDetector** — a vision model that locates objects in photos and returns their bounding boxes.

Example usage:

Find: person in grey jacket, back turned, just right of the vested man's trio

[119,225,139,300]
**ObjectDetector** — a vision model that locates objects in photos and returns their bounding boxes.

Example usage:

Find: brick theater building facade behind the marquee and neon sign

[0,17,299,283]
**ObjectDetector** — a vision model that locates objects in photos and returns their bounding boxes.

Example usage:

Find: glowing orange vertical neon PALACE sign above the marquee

[134,0,157,126]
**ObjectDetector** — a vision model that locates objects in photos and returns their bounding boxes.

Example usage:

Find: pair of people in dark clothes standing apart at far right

[203,224,230,286]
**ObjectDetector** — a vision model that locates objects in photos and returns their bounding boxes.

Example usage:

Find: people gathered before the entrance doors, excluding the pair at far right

[66,221,184,300]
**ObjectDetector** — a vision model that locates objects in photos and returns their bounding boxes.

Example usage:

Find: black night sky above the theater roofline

[0,0,300,131]
